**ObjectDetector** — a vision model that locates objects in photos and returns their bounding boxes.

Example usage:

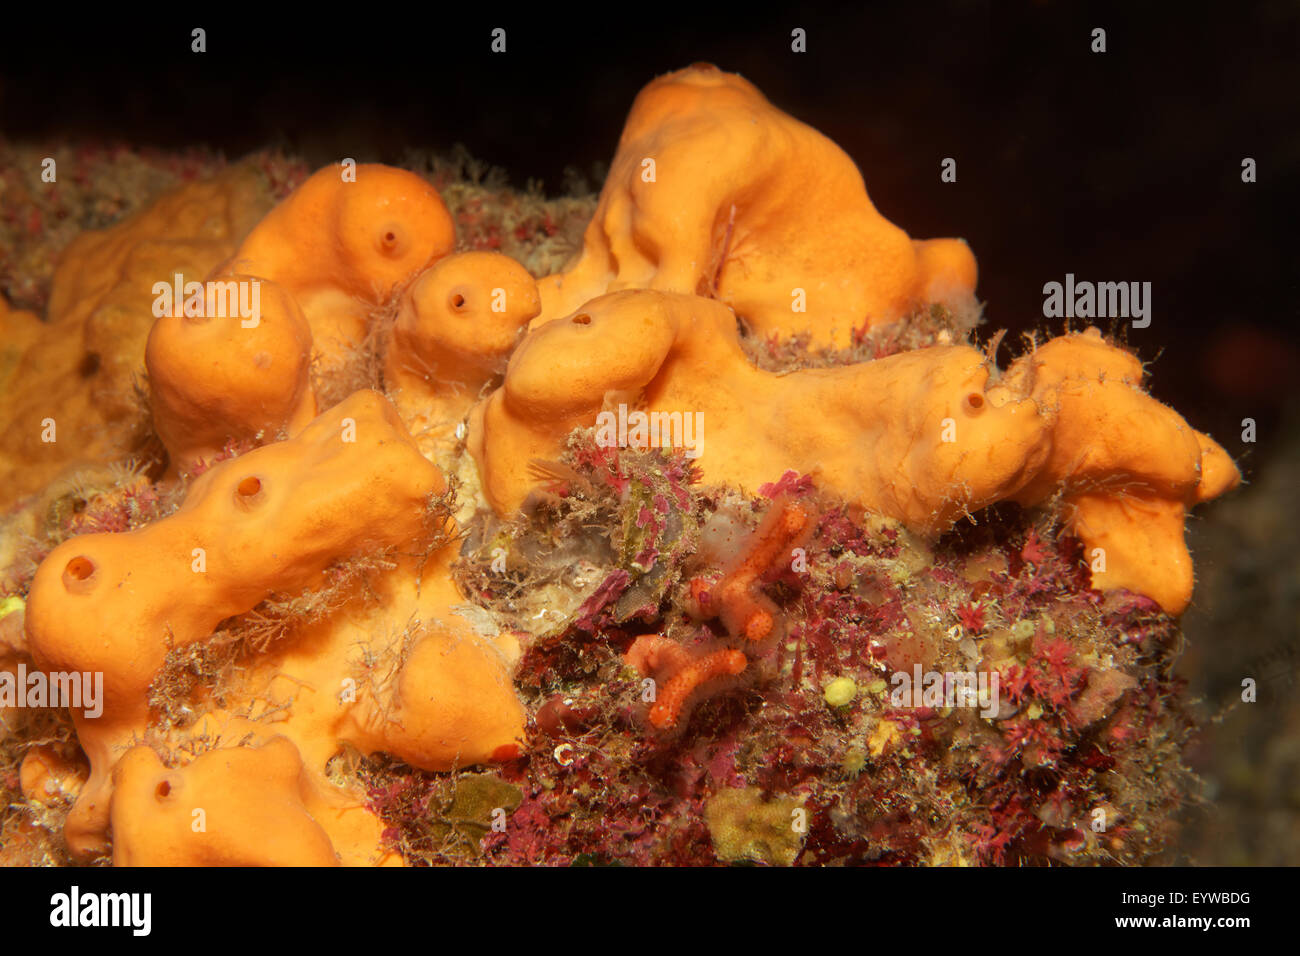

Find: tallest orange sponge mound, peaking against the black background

[538,65,975,347]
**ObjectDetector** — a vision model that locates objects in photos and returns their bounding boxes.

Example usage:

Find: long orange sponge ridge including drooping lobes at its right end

[469,291,1239,614]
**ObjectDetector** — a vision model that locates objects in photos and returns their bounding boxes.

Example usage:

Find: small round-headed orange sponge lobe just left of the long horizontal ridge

[384,252,541,447]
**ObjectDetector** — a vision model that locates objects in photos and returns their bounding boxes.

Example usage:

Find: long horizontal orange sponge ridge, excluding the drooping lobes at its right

[469,291,1050,532]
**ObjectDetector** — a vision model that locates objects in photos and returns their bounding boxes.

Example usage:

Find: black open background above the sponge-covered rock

[0,1,1300,472]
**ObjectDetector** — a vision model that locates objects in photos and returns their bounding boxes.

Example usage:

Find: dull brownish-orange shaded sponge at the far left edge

[0,165,272,496]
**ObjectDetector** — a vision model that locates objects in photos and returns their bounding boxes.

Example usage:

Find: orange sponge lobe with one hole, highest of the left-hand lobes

[225,164,456,367]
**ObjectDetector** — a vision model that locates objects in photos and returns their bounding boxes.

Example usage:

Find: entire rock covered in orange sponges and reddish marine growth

[0,65,1240,865]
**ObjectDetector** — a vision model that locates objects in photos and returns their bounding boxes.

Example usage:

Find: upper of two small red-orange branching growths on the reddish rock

[692,498,813,643]
